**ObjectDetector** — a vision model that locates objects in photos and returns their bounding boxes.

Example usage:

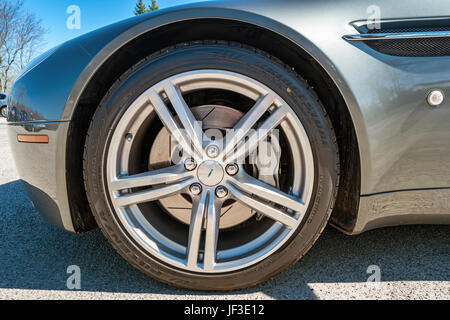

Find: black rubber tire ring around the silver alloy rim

[84,42,339,291]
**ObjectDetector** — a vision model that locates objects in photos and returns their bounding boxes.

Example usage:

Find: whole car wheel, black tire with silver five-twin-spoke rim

[84,42,339,291]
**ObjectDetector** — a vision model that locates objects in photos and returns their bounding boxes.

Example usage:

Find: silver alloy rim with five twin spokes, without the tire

[106,70,315,274]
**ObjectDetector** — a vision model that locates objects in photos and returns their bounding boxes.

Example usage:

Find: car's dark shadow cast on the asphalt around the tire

[0,181,450,299]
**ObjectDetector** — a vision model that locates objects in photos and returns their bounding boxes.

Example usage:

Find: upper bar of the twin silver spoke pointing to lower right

[230,172,306,216]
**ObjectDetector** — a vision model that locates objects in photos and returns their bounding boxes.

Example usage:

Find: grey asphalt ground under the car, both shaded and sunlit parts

[0,120,450,300]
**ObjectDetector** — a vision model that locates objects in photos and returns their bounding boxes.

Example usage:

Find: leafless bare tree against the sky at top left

[0,0,45,92]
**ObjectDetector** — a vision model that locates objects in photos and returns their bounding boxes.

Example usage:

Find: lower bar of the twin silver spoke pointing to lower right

[227,183,298,229]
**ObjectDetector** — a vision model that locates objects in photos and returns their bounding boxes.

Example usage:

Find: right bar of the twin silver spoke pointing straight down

[203,191,220,271]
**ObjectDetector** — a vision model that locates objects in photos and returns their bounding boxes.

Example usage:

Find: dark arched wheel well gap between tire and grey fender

[67,19,361,232]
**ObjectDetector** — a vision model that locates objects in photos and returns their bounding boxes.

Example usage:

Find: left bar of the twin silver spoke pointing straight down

[186,192,208,268]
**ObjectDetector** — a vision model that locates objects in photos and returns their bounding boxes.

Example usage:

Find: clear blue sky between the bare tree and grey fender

[24,0,208,51]
